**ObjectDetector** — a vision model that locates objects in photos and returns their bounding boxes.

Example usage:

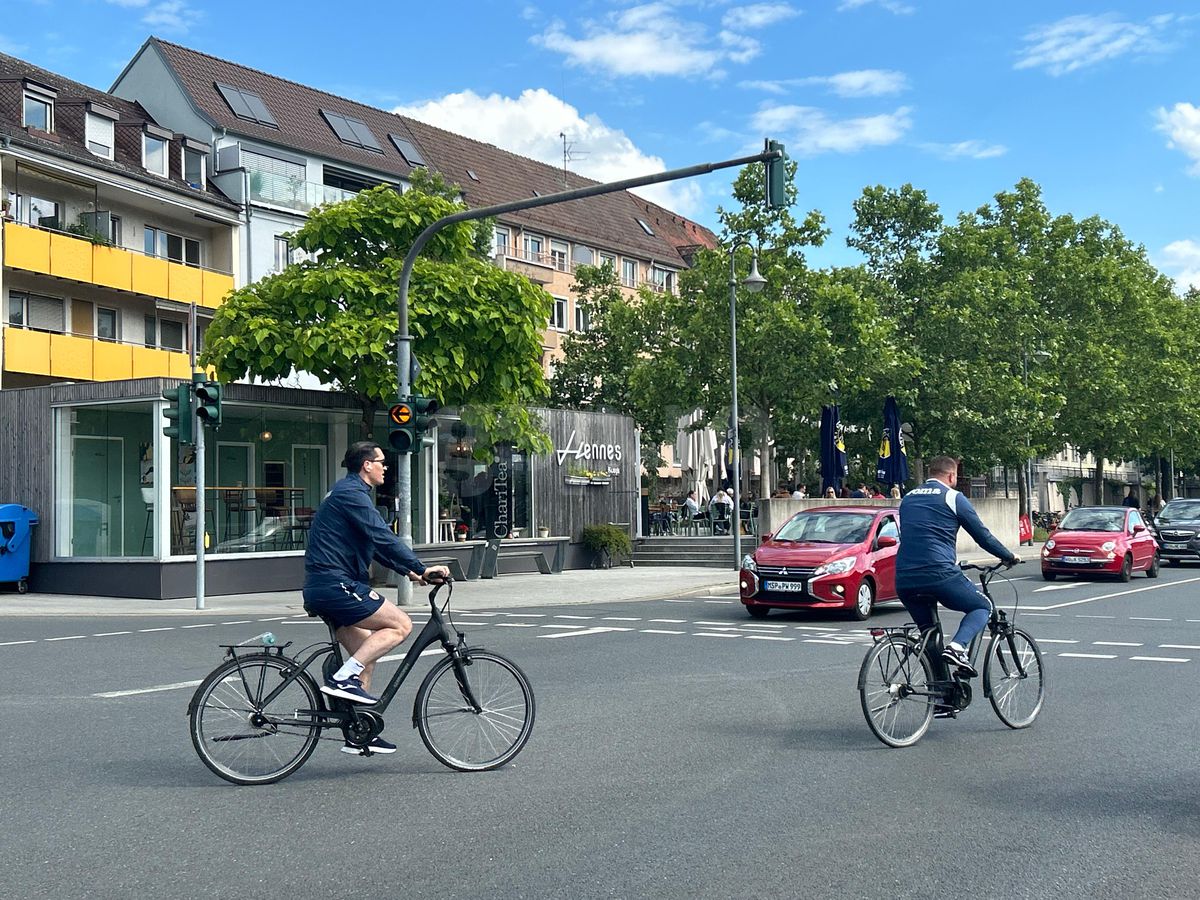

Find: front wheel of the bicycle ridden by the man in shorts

[413,650,534,772]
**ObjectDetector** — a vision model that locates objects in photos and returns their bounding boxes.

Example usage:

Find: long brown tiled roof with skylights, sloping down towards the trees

[146,37,716,266]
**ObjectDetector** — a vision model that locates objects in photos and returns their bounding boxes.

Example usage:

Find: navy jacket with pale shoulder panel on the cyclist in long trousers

[896,478,1013,588]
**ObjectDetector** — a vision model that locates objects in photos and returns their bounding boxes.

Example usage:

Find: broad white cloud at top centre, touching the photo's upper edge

[530,0,774,78]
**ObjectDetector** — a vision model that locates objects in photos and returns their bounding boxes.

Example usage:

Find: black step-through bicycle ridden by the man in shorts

[187,580,534,785]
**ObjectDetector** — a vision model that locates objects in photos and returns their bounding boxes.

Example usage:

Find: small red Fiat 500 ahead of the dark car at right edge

[1042,506,1158,581]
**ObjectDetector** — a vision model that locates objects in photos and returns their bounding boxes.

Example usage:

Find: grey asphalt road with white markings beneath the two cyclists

[0,566,1200,898]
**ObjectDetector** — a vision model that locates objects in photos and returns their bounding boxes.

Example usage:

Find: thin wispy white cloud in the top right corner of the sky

[1014,13,1178,76]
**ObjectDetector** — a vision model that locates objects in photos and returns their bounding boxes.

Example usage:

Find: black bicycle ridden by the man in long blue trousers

[858,563,1046,746]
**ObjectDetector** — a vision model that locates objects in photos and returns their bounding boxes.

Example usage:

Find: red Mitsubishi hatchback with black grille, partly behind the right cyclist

[738,506,900,619]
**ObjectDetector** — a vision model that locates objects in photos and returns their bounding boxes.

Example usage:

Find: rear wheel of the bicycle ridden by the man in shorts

[187,654,323,785]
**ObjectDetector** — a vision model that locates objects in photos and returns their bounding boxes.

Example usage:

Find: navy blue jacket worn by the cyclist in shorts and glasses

[304,475,425,588]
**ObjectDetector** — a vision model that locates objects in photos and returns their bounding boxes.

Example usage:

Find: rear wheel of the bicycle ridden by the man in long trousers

[858,637,934,746]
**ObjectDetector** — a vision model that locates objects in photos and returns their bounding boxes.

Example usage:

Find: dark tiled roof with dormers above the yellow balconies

[0,53,239,210]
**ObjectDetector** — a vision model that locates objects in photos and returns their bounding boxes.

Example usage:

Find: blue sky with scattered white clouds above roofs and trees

[9,0,1200,286]
